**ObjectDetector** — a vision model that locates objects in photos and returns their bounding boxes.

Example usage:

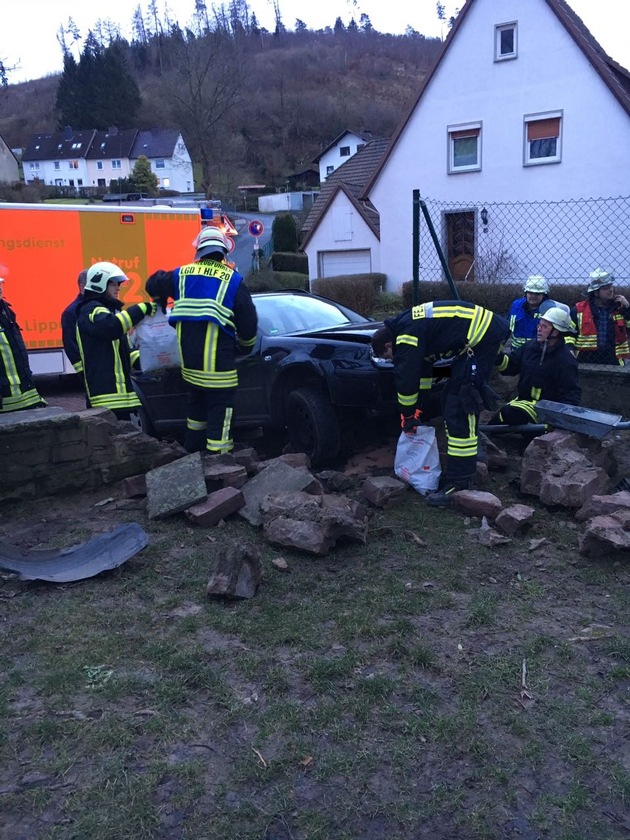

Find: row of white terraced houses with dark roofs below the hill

[22,126,194,192]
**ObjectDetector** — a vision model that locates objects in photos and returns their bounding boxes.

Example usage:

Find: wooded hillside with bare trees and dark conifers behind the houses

[0,5,441,193]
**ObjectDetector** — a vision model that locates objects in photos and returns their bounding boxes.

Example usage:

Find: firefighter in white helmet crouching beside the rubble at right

[489,306,581,426]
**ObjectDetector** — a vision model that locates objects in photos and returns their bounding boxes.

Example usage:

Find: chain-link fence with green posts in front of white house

[419,196,630,285]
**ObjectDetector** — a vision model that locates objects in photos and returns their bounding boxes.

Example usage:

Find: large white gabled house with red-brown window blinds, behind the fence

[310,0,630,289]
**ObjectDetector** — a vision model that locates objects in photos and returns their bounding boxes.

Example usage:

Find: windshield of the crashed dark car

[254,295,359,335]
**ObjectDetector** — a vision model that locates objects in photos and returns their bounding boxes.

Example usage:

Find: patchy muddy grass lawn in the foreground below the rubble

[0,457,630,840]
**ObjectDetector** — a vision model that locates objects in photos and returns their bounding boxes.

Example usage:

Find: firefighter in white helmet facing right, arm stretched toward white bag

[76,262,157,420]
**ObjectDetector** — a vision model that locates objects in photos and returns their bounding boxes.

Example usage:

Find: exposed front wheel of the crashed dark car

[287,388,341,467]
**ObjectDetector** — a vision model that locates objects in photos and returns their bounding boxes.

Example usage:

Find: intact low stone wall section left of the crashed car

[0,407,181,502]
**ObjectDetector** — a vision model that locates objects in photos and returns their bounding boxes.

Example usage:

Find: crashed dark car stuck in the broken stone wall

[133,291,398,466]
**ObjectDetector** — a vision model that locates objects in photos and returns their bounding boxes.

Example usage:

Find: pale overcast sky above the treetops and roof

[0,0,630,82]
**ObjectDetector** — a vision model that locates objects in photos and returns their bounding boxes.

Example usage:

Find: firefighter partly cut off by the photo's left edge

[0,277,46,414]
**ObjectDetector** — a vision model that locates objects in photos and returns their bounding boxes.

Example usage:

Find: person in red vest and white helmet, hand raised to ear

[571,268,630,365]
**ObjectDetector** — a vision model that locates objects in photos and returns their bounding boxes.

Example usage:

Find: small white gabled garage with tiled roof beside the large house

[301,140,388,280]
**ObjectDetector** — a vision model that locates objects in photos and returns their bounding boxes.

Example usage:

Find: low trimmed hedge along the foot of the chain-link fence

[401,280,586,315]
